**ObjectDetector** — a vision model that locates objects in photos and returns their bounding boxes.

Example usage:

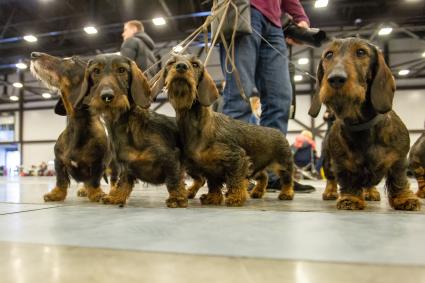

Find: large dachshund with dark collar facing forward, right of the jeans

[309,38,420,210]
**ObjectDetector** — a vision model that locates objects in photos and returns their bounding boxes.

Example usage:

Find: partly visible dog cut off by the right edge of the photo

[409,133,425,198]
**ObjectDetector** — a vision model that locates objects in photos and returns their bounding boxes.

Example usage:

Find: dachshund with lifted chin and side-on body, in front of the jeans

[153,55,294,206]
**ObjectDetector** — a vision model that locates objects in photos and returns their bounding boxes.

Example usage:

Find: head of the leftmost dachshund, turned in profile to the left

[30,52,87,116]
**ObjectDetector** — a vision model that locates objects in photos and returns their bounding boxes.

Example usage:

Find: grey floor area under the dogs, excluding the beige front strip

[0,177,425,282]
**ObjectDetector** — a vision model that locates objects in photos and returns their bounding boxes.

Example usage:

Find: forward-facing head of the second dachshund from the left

[76,54,150,120]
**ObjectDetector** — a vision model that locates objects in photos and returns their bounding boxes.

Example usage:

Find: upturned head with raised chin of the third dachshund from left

[152,54,219,110]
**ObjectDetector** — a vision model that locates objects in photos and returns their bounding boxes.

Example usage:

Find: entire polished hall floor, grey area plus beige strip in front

[0,177,425,283]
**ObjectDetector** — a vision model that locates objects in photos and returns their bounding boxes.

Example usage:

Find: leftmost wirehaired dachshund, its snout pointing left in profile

[31,52,117,201]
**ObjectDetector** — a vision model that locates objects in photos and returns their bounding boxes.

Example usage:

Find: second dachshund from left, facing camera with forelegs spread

[77,54,196,208]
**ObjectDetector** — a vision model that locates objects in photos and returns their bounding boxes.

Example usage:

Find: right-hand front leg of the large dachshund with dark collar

[386,159,421,211]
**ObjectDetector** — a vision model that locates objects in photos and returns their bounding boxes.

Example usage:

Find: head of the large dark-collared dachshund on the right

[309,38,395,120]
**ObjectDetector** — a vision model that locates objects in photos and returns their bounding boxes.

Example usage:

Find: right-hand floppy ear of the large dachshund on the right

[370,47,395,113]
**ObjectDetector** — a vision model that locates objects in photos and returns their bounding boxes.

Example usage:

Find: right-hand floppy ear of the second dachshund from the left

[130,61,151,108]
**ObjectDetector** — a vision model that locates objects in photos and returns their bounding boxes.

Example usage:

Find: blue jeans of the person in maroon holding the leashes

[220,6,292,134]
